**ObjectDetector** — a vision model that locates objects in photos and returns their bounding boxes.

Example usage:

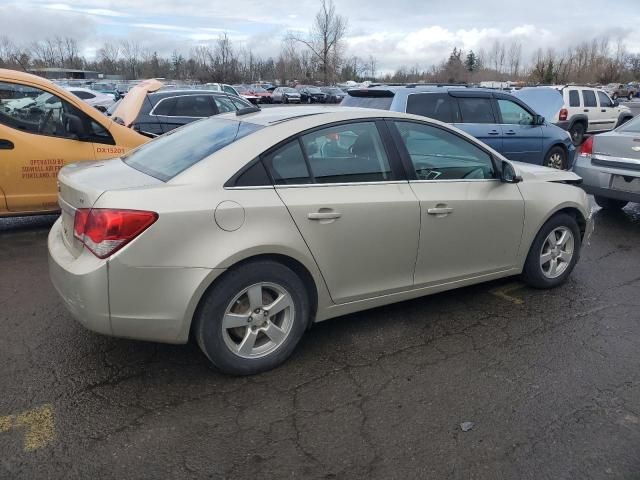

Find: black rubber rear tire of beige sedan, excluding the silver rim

[194,260,309,375]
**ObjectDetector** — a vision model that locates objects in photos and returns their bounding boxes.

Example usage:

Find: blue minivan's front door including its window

[496,97,543,165]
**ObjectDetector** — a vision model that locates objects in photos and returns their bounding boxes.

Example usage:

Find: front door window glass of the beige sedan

[396,122,495,180]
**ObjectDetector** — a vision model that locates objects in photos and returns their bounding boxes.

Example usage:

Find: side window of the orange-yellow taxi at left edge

[0,82,114,144]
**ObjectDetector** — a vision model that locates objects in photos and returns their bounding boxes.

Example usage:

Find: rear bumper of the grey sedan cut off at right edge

[573,155,640,203]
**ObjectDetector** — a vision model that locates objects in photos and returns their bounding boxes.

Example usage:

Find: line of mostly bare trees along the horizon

[0,0,640,84]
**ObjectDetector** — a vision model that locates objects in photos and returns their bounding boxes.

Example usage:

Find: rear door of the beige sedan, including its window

[263,121,420,303]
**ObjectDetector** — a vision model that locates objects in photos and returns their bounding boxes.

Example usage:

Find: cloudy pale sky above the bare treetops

[0,0,640,72]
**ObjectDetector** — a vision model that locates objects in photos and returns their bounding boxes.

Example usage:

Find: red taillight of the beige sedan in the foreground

[73,208,158,258]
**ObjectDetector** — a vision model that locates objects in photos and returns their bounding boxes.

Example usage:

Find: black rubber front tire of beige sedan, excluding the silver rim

[522,213,582,289]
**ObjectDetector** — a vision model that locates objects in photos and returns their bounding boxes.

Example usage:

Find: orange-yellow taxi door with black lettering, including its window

[0,82,96,213]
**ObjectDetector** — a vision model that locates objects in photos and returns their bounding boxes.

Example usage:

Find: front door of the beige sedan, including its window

[394,121,524,286]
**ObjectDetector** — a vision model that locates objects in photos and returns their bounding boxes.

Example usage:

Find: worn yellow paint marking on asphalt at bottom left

[0,403,56,452]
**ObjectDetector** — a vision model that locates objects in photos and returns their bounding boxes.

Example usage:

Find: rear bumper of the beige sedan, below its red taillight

[48,220,224,343]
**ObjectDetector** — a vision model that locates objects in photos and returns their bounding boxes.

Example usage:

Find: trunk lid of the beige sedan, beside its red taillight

[58,158,163,257]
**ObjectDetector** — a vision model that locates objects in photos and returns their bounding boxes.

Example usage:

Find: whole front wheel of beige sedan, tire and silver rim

[522,213,582,289]
